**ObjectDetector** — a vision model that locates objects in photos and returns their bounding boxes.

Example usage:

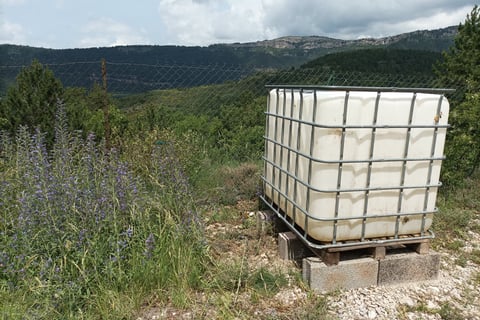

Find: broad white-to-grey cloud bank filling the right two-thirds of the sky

[158,0,475,45]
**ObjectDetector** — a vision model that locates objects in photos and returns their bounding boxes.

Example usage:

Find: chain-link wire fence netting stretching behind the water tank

[0,61,464,109]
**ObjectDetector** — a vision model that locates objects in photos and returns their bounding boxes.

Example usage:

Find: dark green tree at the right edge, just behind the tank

[436,6,480,185]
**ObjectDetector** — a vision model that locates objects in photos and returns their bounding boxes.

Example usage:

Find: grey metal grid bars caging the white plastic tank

[261,85,454,249]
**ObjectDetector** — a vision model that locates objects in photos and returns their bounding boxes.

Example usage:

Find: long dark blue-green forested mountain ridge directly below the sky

[0,26,457,95]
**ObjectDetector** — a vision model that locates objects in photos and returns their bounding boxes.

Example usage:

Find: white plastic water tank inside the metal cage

[263,87,449,243]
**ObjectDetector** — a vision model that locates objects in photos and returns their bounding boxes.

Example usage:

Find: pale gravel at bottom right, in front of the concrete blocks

[327,254,480,320]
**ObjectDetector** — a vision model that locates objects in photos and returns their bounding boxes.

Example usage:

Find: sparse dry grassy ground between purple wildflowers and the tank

[138,200,328,319]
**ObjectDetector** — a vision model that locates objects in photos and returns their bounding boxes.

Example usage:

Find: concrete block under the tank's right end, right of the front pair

[378,250,440,285]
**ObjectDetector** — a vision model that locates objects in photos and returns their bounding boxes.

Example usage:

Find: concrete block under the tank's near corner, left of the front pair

[302,257,378,291]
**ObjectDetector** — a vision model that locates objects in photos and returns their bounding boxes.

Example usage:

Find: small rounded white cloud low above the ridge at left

[79,18,150,47]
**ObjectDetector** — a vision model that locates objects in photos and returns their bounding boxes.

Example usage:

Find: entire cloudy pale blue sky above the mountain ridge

[0,0,480,49]
